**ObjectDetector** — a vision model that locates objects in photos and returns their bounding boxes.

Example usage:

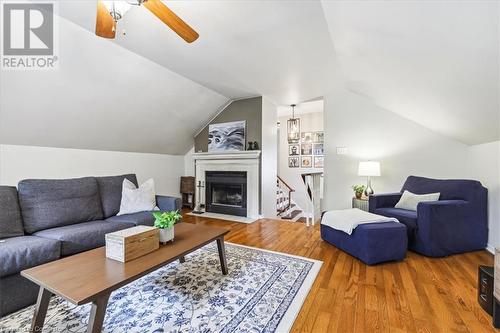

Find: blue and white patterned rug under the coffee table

[0,243,322,333]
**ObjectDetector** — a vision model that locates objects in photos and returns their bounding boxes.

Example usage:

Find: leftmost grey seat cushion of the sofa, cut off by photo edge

[0,236,61,277]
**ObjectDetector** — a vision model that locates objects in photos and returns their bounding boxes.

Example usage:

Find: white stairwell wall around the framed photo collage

[278,111,323,210]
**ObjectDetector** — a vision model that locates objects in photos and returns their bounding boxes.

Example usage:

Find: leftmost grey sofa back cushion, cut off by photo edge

[0,186,24,239]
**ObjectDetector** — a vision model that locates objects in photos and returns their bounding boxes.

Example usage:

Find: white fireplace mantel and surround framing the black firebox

[193,150,261,219]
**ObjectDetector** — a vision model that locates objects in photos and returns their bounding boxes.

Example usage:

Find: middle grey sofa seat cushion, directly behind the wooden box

[35,220,134,256]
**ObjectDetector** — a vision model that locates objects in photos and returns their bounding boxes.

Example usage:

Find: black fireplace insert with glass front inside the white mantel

[205,171,247,216]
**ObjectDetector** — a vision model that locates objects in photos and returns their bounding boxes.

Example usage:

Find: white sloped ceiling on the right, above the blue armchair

[323,1,500,144]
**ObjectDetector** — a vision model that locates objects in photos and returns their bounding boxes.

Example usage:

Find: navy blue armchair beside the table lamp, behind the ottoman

[369,176,488,257]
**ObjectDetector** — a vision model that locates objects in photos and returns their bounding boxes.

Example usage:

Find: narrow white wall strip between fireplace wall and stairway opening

[260,97,278,217]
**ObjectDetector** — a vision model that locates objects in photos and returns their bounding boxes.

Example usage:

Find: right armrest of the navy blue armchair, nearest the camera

[417,200,488,257]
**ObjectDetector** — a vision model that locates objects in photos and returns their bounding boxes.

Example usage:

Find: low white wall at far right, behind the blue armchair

[467,141,500,249]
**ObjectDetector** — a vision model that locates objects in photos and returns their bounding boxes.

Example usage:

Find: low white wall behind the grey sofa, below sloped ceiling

[0,145,184,196]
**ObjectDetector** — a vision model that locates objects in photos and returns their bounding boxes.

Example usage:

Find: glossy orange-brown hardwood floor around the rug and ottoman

[184,215,500,333]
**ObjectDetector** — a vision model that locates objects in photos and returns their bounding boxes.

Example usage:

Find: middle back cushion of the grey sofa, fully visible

[18,177,103,234]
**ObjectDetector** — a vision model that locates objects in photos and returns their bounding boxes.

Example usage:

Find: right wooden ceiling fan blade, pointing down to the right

[144,0,199,43]
